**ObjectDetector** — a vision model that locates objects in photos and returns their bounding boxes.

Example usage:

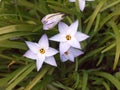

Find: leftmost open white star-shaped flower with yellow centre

[24,34,58,71]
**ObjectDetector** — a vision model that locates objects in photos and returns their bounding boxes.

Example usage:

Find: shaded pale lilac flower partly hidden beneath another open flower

[60,47,83,62]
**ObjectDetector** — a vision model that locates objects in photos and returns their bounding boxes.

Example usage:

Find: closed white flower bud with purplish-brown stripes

[41,13,65,30]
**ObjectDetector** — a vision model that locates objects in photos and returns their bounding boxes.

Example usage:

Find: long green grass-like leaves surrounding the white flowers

[0,0,120,90]
